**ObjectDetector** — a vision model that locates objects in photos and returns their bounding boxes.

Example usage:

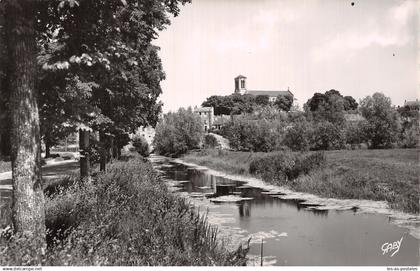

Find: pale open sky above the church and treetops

[154,0,420,112]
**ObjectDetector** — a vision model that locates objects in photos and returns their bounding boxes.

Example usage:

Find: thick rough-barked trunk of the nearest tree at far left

[6,0,45,246]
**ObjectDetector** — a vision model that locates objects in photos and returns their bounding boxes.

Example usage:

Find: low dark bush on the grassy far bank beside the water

[249,152,325,185]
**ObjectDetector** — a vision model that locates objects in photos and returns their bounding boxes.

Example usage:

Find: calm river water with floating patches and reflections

[154,160,420,265]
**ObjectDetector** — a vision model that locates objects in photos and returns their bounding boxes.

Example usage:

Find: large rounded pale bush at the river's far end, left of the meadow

[153,108,204,156]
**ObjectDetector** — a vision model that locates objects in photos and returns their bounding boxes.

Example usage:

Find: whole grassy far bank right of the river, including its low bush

[182,149,420,214]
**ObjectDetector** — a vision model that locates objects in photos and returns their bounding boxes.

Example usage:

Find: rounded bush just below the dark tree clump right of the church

[311,121,346,150]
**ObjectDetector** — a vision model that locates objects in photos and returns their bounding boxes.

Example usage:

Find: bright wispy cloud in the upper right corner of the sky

[312,1,417,61]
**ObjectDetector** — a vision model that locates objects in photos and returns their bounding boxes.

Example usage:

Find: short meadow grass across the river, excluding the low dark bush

[183,149,420,213]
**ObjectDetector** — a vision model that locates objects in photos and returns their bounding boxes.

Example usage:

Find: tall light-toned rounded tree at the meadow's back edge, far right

[360,92,398,149]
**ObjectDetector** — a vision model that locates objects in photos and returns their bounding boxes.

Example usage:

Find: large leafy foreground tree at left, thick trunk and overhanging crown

[0,0,188,255]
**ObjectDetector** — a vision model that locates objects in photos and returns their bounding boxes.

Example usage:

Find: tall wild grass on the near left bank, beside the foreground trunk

[0,158,247,266]
